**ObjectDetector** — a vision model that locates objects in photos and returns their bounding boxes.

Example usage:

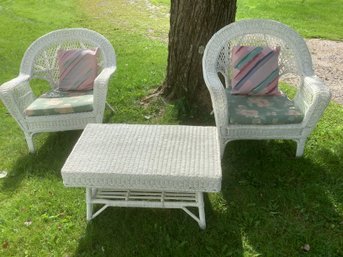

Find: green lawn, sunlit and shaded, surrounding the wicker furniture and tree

[0,0,343,257]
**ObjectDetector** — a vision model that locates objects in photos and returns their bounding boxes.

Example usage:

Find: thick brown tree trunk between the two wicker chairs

[163,0,236,109]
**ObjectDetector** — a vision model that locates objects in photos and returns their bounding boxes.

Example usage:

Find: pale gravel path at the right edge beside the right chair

[306,39,343,105]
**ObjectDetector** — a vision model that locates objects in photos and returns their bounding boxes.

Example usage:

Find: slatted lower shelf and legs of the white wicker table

[86,188,206,229]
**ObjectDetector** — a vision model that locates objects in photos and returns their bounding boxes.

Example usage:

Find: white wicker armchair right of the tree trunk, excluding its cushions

[202,19,331,157]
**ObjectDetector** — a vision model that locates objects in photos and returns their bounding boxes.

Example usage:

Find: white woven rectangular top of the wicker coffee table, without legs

[62,124,222,192]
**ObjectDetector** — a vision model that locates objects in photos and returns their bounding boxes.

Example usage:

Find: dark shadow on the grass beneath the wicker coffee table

[73,184,243,257]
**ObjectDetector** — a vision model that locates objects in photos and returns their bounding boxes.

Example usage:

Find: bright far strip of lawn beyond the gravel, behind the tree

[152,0,343,40]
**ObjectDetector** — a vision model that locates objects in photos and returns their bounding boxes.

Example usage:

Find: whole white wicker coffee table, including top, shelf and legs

[62,124,222,229]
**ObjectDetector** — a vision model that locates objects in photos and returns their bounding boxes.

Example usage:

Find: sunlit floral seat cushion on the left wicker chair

[24,89,93,116]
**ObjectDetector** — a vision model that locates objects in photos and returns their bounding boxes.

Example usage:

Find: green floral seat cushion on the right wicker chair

[226,91,304,125]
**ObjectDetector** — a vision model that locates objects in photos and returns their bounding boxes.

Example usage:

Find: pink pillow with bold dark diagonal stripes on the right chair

[231,46,281,95]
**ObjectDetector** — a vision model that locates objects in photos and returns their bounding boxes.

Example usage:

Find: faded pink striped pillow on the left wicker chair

[57,48,98,91]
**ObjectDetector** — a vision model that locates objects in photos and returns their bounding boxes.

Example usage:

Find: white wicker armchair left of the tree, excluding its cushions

[0,28,116,152]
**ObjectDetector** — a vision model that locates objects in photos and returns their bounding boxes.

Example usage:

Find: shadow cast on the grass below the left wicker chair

[1,131,81,191]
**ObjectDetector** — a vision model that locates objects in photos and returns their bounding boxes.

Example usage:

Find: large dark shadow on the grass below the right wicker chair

[222,141,343,256]
